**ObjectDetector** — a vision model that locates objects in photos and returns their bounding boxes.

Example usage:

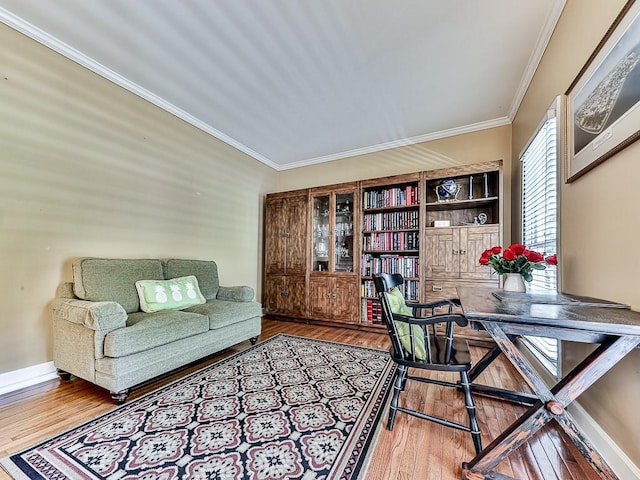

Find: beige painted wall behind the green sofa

[0,24,277,373]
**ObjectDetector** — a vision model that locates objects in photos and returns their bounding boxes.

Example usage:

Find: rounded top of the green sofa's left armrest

[51,298,127,331]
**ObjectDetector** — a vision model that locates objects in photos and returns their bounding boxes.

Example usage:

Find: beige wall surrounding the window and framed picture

[513,0,640,465]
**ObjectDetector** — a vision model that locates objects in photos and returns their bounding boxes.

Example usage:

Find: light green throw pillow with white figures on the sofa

[136,275,206,313]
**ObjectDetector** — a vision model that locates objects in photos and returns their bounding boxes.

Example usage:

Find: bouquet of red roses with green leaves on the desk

[480,243,558,282]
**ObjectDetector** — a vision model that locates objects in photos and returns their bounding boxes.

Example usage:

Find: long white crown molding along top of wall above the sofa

[0,7,278,170]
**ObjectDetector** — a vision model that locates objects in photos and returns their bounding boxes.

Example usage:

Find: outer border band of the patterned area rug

[0,333,394,480]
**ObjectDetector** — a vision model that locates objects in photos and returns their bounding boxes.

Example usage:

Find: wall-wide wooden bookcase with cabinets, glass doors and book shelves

[263,161,503,334]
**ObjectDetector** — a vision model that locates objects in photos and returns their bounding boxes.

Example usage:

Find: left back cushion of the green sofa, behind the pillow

[73,258,164,313]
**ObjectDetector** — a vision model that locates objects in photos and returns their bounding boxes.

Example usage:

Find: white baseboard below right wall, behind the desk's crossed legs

[567,402,640,480]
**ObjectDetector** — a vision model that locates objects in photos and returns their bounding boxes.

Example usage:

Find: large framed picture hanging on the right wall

[565,0,640,183]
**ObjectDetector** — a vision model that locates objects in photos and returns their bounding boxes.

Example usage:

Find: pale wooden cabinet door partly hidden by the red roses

[460,225,500,280]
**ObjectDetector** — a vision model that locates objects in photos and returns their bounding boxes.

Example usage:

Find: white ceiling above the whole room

[0,0,565,170]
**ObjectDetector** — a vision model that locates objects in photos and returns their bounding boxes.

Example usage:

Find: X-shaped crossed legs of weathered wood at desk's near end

[463,322,640,480]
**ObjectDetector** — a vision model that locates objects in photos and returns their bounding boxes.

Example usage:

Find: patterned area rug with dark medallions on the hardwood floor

[1,335,394,480]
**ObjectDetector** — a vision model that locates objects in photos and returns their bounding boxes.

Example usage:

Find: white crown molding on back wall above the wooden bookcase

[278,117,511,171]
